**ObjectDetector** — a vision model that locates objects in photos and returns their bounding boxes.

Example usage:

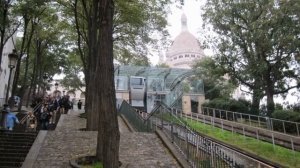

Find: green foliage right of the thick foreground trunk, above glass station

[114,0,171,65]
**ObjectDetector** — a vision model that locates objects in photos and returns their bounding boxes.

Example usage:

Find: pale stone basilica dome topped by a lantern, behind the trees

[165,14,204,69]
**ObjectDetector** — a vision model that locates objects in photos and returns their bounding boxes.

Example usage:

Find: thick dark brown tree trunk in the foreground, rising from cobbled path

[88,0,120,168]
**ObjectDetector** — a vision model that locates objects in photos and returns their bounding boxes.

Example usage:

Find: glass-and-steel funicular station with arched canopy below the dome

[115,66,205,113]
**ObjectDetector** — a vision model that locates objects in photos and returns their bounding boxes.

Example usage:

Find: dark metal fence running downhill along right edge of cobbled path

[120,102,273,168]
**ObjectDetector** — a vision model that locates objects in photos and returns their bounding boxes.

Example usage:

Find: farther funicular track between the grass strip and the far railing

[183,113,300,151]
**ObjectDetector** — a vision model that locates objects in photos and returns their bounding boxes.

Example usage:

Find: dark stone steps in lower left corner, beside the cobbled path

[0,131,38,168]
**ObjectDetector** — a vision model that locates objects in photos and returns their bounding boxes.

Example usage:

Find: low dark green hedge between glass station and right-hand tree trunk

[203,98,251,114]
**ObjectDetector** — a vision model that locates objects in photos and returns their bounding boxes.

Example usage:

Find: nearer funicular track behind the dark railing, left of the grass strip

[146,114,282,168]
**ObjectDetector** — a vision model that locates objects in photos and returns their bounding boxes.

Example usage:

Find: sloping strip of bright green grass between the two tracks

[185,120,300,168]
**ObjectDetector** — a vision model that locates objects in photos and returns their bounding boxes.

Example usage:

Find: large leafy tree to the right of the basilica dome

[203,0,300,115]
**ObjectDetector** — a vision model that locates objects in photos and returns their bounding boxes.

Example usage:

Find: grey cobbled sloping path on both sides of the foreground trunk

[29,111,180,168]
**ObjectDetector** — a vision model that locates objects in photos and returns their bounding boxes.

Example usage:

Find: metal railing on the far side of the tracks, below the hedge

[202,107,300,136]
